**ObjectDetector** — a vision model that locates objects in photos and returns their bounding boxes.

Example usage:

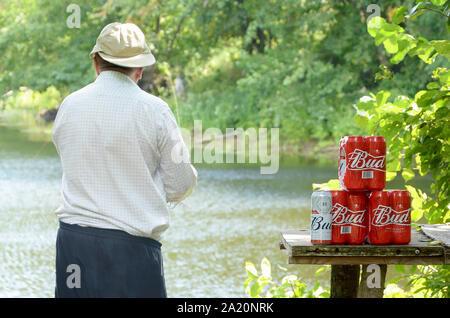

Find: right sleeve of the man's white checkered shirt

[158,106,197,203]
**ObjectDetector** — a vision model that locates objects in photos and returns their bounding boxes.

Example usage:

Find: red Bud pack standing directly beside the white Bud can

[331,190,367,244]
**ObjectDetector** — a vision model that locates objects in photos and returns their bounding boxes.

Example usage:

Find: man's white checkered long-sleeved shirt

[52,71,197,240]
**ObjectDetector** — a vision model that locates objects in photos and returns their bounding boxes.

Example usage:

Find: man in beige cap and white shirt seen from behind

[52,23,197,297]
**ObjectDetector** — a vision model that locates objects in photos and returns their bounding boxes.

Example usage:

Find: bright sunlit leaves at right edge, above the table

[362,2,450,223]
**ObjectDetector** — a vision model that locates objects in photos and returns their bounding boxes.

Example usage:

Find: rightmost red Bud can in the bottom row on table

[389,190,411,244]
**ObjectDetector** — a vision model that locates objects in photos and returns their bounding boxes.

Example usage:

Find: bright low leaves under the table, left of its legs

[244,258,330,298]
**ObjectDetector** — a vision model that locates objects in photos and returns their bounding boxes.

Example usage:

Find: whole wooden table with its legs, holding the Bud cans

[280,223,450,298]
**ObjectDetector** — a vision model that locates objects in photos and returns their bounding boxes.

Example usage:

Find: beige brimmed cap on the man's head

[89,22,155,67]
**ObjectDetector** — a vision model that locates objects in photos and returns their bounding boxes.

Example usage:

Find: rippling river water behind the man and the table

[0,126,427,297]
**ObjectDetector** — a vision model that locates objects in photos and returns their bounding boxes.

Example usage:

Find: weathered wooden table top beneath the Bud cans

[280,224,450,265]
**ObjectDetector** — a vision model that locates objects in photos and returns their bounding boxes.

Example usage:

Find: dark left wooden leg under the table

[330,265,360,298]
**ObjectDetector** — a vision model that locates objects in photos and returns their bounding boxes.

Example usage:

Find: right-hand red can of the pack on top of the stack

[363,136,386,191]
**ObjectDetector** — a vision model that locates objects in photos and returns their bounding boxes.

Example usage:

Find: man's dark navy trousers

[55,222,167,298]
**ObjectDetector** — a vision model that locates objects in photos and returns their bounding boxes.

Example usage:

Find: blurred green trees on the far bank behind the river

[0,0,447,146]
